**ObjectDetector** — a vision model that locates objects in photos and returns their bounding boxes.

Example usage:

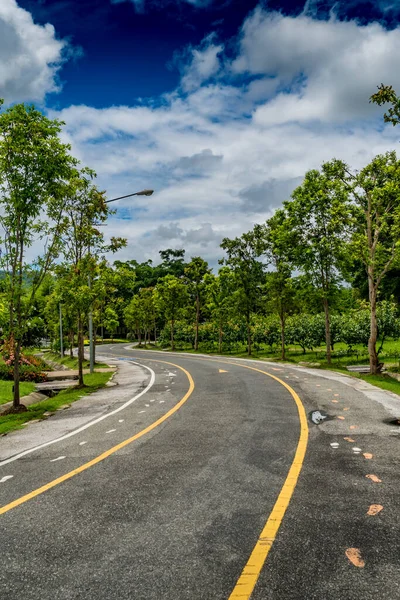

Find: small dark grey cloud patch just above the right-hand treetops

[239,177,303,214]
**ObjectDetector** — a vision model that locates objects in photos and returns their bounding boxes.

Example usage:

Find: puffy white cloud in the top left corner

[0,0,66,104]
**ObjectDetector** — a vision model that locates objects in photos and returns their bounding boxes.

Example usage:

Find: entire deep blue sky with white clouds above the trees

[0,0,400,264]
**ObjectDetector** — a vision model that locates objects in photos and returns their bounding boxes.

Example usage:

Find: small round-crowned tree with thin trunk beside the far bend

[154,275,189,350]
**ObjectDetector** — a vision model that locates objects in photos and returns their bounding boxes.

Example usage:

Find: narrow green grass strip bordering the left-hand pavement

[0,372,113,435]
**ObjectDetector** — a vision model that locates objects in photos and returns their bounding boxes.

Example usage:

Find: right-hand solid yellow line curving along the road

[224,361,308,600]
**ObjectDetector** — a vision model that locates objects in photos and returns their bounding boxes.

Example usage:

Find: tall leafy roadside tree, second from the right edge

[285,170,349,364]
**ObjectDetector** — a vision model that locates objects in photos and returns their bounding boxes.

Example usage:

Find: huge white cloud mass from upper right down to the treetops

[52,9,400,265]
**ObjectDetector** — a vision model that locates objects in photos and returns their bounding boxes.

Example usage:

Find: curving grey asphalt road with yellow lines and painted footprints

[0,346,400,600]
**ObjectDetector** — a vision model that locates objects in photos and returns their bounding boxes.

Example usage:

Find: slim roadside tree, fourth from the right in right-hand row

[220,231,264,356]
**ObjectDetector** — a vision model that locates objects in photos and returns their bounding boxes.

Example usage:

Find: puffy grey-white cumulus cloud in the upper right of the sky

[232,8,400,125]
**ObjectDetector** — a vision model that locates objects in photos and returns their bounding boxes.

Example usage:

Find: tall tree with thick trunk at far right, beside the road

[325,152,400,374]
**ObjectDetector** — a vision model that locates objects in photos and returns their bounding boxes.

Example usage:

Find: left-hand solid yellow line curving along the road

[0,360,194,515]
